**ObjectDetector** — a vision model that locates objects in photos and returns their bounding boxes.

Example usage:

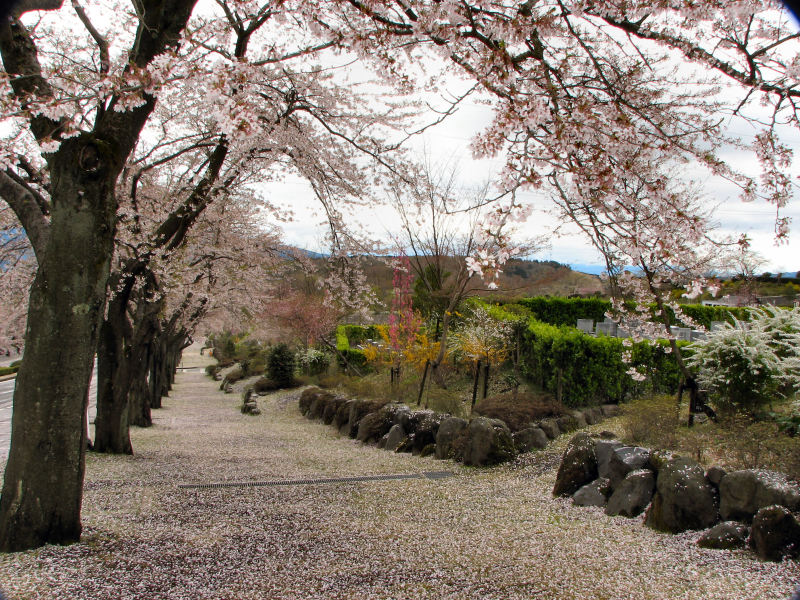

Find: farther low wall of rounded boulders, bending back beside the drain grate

[299,387,619,466]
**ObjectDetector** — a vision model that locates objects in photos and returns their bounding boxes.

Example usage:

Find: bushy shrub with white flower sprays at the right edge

[686,307,800,412]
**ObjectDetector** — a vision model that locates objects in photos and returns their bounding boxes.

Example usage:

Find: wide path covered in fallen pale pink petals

[0,346,800,600]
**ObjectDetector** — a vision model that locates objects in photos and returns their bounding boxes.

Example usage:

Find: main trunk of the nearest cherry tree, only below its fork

[0,142,118,551]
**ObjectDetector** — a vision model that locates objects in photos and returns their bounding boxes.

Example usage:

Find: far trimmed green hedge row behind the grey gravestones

[510,296,748,328]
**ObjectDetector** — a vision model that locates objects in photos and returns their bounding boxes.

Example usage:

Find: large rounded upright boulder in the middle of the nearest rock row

[645,456,719,533]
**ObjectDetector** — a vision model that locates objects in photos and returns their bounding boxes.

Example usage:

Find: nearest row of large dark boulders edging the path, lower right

[553,432,800,560]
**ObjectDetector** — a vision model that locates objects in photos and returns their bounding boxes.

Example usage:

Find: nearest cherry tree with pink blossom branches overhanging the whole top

[0,0,800,550]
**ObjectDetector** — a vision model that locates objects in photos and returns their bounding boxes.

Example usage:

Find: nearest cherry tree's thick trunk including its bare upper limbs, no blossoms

[0,0,195,551]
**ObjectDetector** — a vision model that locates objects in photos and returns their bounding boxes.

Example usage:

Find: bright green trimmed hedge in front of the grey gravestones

[521,320,687,407]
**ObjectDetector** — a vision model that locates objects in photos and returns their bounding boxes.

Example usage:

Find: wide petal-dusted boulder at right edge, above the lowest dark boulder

[719,469,800,521]
